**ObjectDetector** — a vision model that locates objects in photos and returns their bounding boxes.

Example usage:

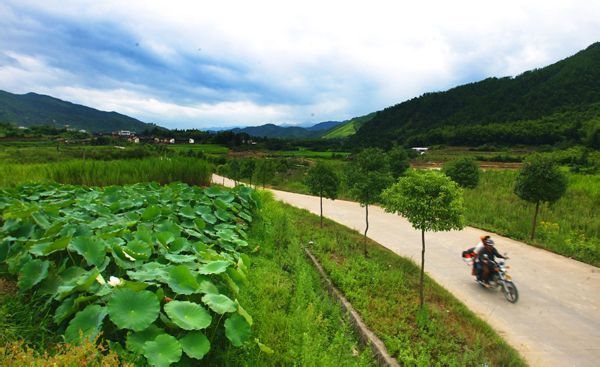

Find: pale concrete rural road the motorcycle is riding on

[213,175,600,367]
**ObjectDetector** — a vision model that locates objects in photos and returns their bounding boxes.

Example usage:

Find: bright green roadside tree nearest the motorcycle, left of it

[381,171,464,308]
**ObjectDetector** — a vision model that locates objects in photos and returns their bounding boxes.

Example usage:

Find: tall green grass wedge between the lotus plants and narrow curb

[207,194,375,366]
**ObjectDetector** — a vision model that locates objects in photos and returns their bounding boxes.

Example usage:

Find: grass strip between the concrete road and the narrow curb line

[258,194,524,366]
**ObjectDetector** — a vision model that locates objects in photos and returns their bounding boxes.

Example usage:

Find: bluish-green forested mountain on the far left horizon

[0,90,155,132]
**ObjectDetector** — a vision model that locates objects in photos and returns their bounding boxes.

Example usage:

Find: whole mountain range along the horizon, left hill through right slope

[0,42,600,146]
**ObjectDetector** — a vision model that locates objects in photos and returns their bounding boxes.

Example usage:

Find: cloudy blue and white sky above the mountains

[0,0,600,129]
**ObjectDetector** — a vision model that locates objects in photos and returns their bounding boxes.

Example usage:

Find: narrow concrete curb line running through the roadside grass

[304,247,400,367]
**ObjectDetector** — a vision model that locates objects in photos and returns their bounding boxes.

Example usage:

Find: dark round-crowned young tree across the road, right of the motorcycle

[515,154,567,241]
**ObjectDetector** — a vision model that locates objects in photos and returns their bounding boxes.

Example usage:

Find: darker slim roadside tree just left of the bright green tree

[346,148,392,256]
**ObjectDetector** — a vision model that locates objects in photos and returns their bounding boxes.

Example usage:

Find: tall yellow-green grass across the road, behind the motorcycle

[465,171,600,266]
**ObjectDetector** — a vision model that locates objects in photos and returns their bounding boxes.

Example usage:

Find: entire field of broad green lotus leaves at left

[0,183,260,366]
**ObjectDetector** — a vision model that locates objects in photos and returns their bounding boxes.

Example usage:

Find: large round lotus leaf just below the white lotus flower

[108,288,160,331]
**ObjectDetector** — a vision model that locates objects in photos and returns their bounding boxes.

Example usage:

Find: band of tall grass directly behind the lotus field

[0,157,212,187]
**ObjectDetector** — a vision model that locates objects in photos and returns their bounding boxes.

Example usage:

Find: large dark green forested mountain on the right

[352,43,600,146]
